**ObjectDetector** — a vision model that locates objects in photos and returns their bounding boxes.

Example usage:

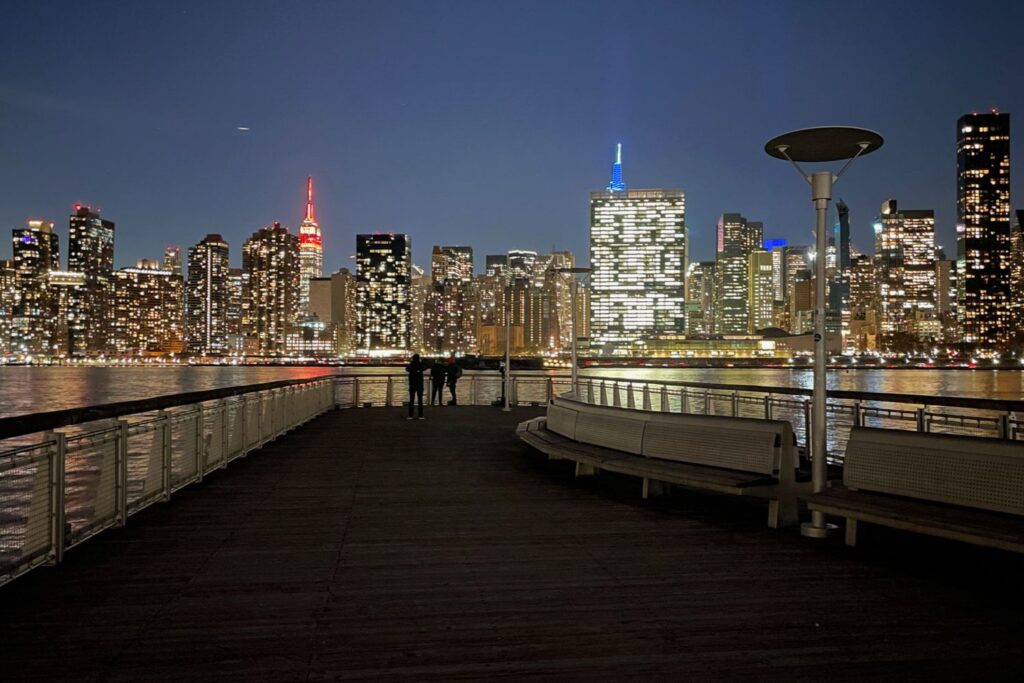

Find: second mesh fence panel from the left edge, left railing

[65,426,120,547]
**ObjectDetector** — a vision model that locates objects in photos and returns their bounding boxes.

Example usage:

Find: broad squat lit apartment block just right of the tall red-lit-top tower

[111,259,185,356]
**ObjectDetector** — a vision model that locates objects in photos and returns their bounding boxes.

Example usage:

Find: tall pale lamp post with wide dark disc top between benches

[765,126,883,539]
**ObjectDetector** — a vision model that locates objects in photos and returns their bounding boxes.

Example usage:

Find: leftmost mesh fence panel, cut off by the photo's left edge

[0,439,55,584]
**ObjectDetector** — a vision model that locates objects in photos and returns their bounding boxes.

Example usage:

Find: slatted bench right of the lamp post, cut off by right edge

[807,427,1024,553]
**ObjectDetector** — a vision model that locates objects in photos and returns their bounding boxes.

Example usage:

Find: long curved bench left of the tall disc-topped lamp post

[516,397,800,528]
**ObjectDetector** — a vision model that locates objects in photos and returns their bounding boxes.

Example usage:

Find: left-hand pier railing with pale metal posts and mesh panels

[0,377,335,585]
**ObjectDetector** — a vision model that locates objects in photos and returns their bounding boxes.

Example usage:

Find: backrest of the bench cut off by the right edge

[843,427,1024,515]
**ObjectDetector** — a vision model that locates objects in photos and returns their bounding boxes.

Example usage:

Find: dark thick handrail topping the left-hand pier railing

[0,374,338,439]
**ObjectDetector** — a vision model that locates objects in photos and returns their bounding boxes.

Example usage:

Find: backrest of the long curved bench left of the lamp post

[548,398,794,474]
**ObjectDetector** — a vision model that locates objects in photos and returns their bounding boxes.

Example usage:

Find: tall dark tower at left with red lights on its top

[68,204,114,355]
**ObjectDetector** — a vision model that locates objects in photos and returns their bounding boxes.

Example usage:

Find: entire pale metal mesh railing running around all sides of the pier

[0,372,1024,585]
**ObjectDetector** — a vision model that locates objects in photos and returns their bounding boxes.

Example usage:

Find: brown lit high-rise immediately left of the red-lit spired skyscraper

[242,222,299,355]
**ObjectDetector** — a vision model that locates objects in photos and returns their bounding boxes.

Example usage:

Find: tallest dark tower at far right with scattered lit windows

[956,112,1011,350]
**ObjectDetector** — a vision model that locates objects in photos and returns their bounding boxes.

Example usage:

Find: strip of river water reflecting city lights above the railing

[0,367,1024,417]
